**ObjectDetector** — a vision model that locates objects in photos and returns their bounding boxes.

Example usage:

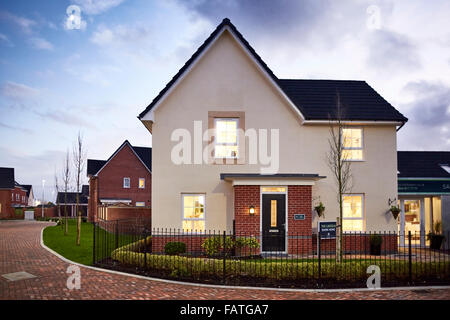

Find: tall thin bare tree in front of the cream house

[327,92,353,262]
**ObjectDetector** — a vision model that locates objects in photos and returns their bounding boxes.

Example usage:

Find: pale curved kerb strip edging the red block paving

[40,224,450,293]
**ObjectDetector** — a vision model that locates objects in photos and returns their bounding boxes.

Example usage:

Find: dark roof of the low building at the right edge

[397,151,450,178]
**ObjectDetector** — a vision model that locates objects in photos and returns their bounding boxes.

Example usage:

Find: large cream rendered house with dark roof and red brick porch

[138,19,408,253]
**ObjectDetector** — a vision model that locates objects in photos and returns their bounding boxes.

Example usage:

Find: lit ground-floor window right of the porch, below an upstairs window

[342,195,364,232]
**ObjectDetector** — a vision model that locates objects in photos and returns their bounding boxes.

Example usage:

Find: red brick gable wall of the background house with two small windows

[98,145,152,206]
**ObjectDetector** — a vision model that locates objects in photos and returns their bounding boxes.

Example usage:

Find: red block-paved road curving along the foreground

[0,221,450,300]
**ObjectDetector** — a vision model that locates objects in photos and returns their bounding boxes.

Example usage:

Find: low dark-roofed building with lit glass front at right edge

[397,151,450,247]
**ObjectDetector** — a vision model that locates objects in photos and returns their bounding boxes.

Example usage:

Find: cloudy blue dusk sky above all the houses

[0,0,450,201]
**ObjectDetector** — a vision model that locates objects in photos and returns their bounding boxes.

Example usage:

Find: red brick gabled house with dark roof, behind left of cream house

[87,140,152,221]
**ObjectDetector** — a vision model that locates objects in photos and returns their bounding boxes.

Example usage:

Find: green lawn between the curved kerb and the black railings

[43,219,93,265]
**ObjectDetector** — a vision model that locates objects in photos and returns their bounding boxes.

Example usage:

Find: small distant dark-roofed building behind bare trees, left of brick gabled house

[56,185,89,218]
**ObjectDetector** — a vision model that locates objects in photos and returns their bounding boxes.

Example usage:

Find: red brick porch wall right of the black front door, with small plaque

[288,186,312,254]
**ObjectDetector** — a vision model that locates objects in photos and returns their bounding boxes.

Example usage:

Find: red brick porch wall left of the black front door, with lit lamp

[234,186,261,236]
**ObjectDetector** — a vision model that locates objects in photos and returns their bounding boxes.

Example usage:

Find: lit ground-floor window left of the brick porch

[183,194,205,232]
